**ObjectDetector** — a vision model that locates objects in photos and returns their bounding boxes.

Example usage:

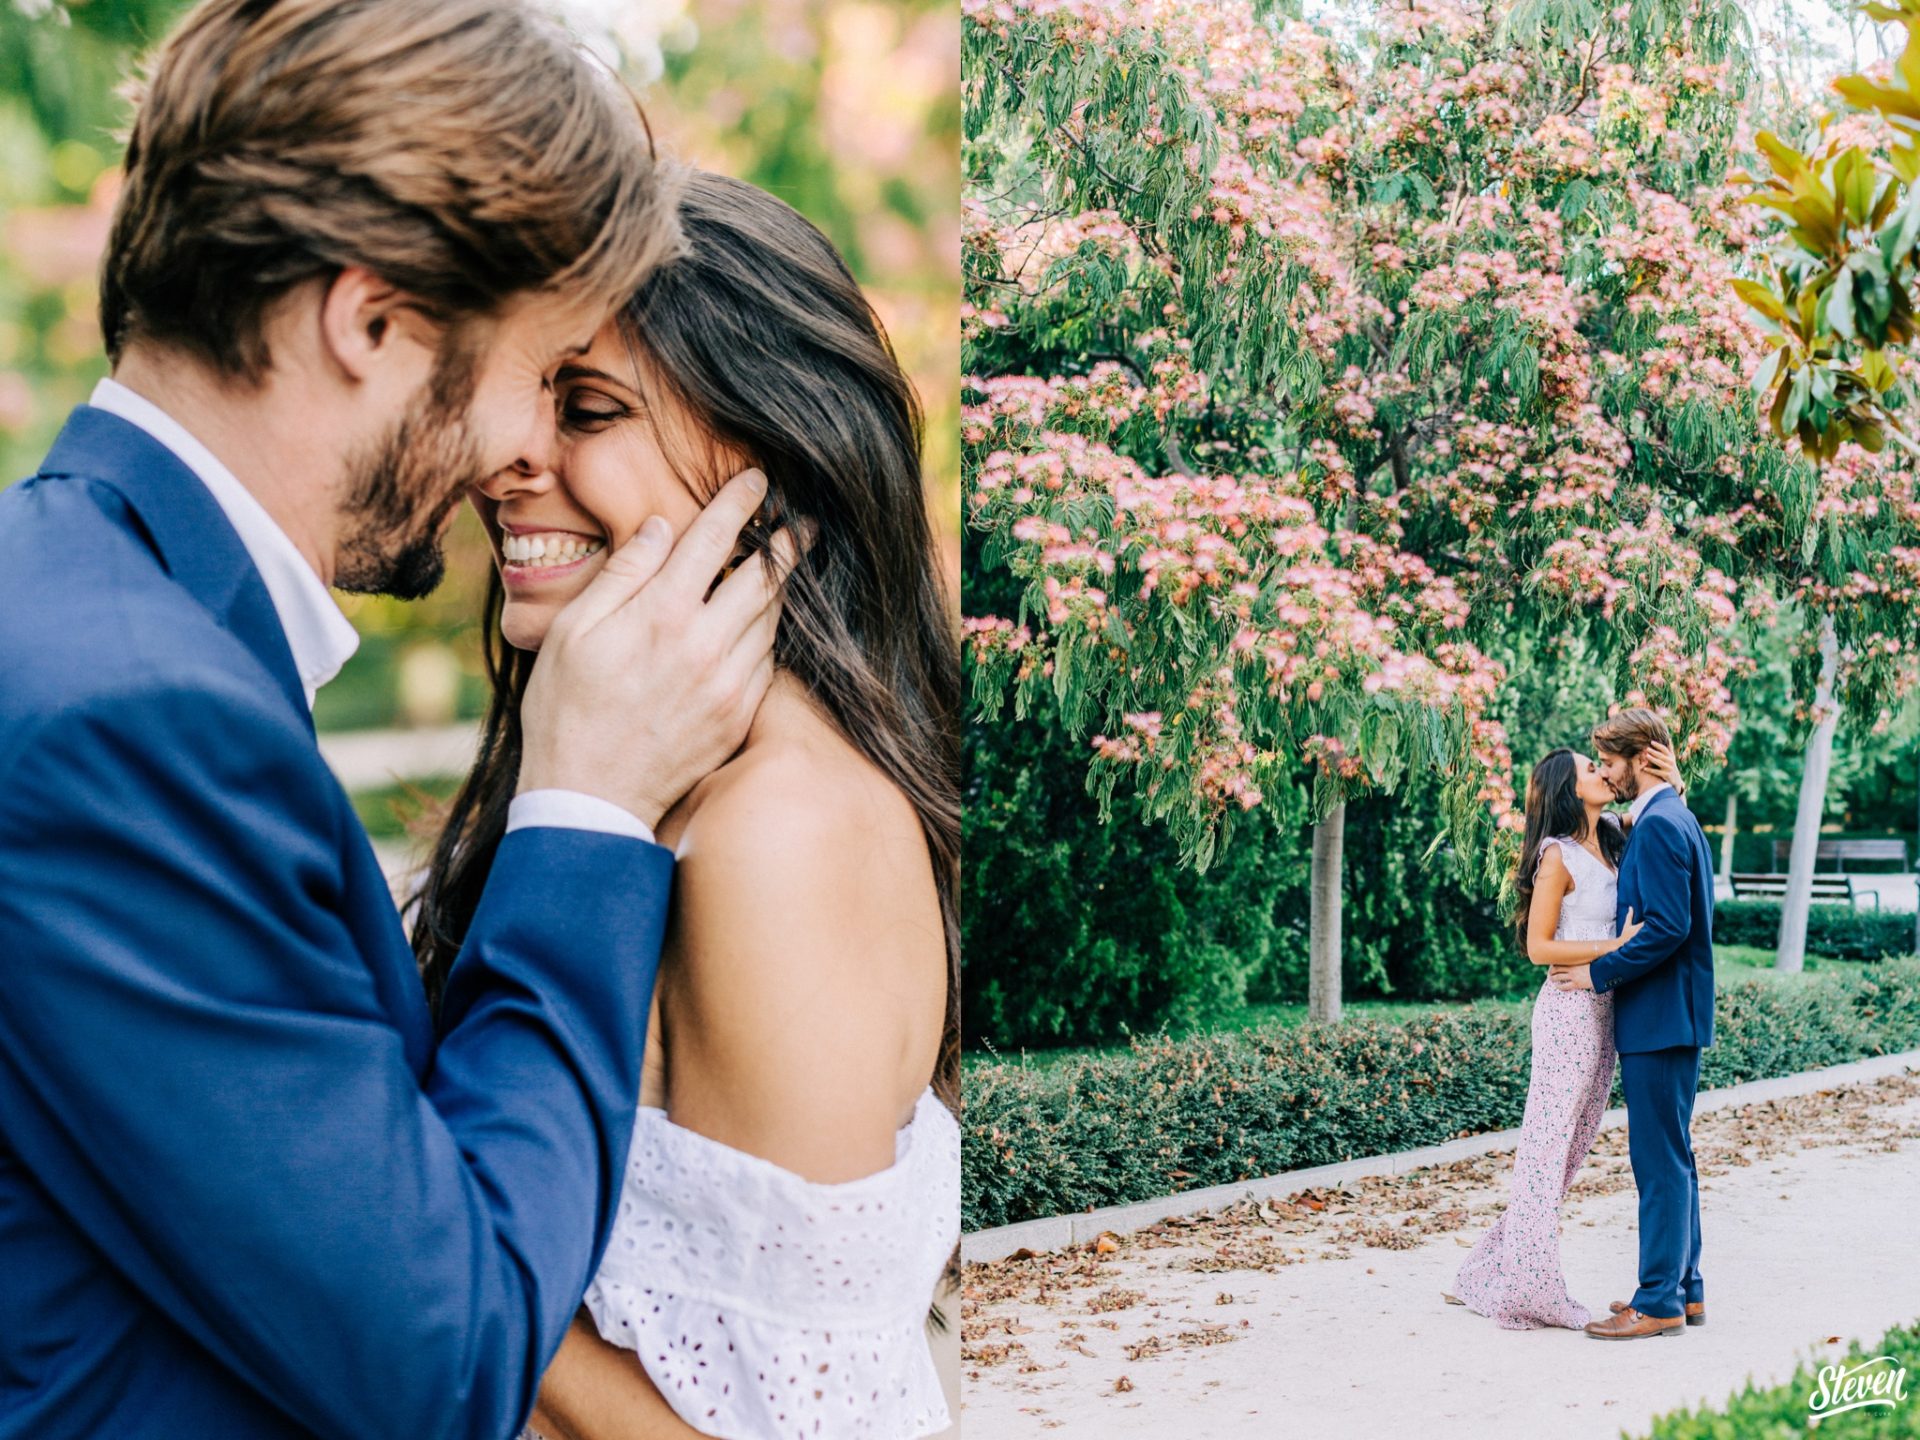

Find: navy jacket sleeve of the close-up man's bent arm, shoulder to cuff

[0,676,672,1440]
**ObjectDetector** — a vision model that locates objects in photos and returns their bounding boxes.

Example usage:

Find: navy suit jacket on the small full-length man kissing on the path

[1588,789,1713,1052]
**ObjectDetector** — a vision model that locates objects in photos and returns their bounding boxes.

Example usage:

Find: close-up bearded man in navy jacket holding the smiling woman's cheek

[0,0,793,1440]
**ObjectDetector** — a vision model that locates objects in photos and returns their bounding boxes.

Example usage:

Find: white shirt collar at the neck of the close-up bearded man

[88,378,359,707]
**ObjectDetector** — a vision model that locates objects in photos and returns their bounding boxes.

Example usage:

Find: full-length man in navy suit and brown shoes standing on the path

[1549,708,1713,1340]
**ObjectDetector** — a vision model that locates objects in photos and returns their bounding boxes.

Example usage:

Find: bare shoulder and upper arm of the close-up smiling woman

[660,698,947,1181]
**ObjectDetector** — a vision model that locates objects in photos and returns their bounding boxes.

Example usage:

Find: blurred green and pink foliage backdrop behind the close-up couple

[0,0,960,806]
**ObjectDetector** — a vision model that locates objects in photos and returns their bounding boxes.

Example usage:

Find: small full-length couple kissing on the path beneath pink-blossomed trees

[1444,708,1713,1340]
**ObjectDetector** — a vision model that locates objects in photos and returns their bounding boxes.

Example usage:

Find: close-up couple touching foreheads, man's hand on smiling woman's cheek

[0,0,960,1440]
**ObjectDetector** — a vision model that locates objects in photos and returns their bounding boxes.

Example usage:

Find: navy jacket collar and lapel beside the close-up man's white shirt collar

[40,405,313,730]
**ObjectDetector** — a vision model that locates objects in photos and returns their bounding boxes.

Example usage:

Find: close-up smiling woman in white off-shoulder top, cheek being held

[415,173,960,1440]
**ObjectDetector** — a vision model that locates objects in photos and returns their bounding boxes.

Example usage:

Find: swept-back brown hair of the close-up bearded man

[100,0,680,382]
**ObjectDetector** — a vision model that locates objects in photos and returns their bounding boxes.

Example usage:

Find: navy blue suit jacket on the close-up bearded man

[0,407,672,1440]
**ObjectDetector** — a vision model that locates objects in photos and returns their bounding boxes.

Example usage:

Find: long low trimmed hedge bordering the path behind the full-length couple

[962,960,1920,1231]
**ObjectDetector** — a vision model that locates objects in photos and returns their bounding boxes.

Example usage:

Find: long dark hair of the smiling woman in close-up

[413,171,960,1110]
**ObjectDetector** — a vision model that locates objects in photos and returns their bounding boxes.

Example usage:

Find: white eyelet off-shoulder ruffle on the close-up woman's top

[586,1087,960,1440]
